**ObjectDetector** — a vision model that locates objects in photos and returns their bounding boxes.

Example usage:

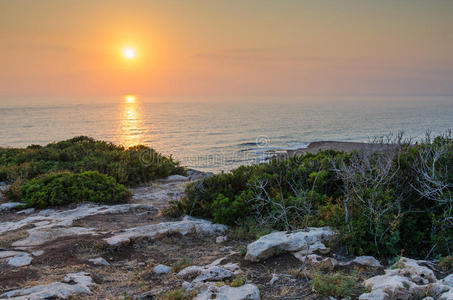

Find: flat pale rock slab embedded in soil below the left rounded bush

[13,227,96,247]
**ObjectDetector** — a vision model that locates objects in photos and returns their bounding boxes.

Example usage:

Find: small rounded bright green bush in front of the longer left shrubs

[19,171,131,208]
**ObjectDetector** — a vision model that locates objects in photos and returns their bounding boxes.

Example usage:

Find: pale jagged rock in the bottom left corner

[0,272,94,300]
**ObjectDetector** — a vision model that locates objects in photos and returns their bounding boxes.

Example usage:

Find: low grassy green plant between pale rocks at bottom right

[310,272,364,299]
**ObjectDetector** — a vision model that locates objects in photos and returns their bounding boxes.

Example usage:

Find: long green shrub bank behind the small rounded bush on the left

[0,136,185,186]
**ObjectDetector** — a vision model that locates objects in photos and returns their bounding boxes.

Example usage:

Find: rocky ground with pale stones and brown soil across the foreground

[0,172,453,300]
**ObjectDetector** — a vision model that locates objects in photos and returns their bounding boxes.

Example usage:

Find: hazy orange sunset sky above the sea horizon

[0,0,453,101]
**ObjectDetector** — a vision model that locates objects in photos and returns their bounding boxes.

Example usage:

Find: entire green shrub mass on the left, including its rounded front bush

[0,136,185,208]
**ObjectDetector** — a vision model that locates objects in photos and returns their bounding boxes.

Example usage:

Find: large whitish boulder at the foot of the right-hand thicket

[245,227,335,262]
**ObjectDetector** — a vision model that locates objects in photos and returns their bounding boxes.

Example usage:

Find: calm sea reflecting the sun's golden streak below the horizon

[0,97,453,171]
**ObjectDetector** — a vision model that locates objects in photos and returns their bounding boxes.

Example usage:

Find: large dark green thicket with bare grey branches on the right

[172,134,453,258]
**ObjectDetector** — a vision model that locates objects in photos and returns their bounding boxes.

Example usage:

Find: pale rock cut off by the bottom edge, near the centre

[193,284,260,300]
